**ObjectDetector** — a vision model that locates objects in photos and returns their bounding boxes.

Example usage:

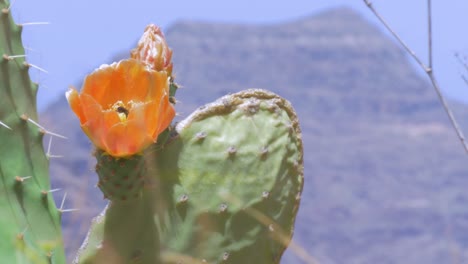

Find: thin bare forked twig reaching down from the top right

[363,0,468,154]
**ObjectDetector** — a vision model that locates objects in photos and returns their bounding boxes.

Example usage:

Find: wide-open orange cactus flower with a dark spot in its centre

[66,59,175,157]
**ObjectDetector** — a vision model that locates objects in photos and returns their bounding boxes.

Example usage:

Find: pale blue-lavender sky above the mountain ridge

[12,0,468,108]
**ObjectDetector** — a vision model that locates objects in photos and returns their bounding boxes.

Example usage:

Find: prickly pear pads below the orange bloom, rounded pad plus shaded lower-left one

[76,90,303,264]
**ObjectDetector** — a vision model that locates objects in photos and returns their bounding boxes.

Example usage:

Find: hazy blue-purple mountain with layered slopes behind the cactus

[42,9,468,264]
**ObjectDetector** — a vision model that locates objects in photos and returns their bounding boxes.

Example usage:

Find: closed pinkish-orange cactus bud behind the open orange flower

[131,24,172,76]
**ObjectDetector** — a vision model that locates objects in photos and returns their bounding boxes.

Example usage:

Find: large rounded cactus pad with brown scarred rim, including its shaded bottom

[158,90,303,263]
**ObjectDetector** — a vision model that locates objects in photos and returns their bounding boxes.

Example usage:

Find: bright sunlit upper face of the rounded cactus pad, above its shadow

[166,90,302,212]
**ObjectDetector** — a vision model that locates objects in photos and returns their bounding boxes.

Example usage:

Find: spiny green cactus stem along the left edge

[0,0,65,263]
